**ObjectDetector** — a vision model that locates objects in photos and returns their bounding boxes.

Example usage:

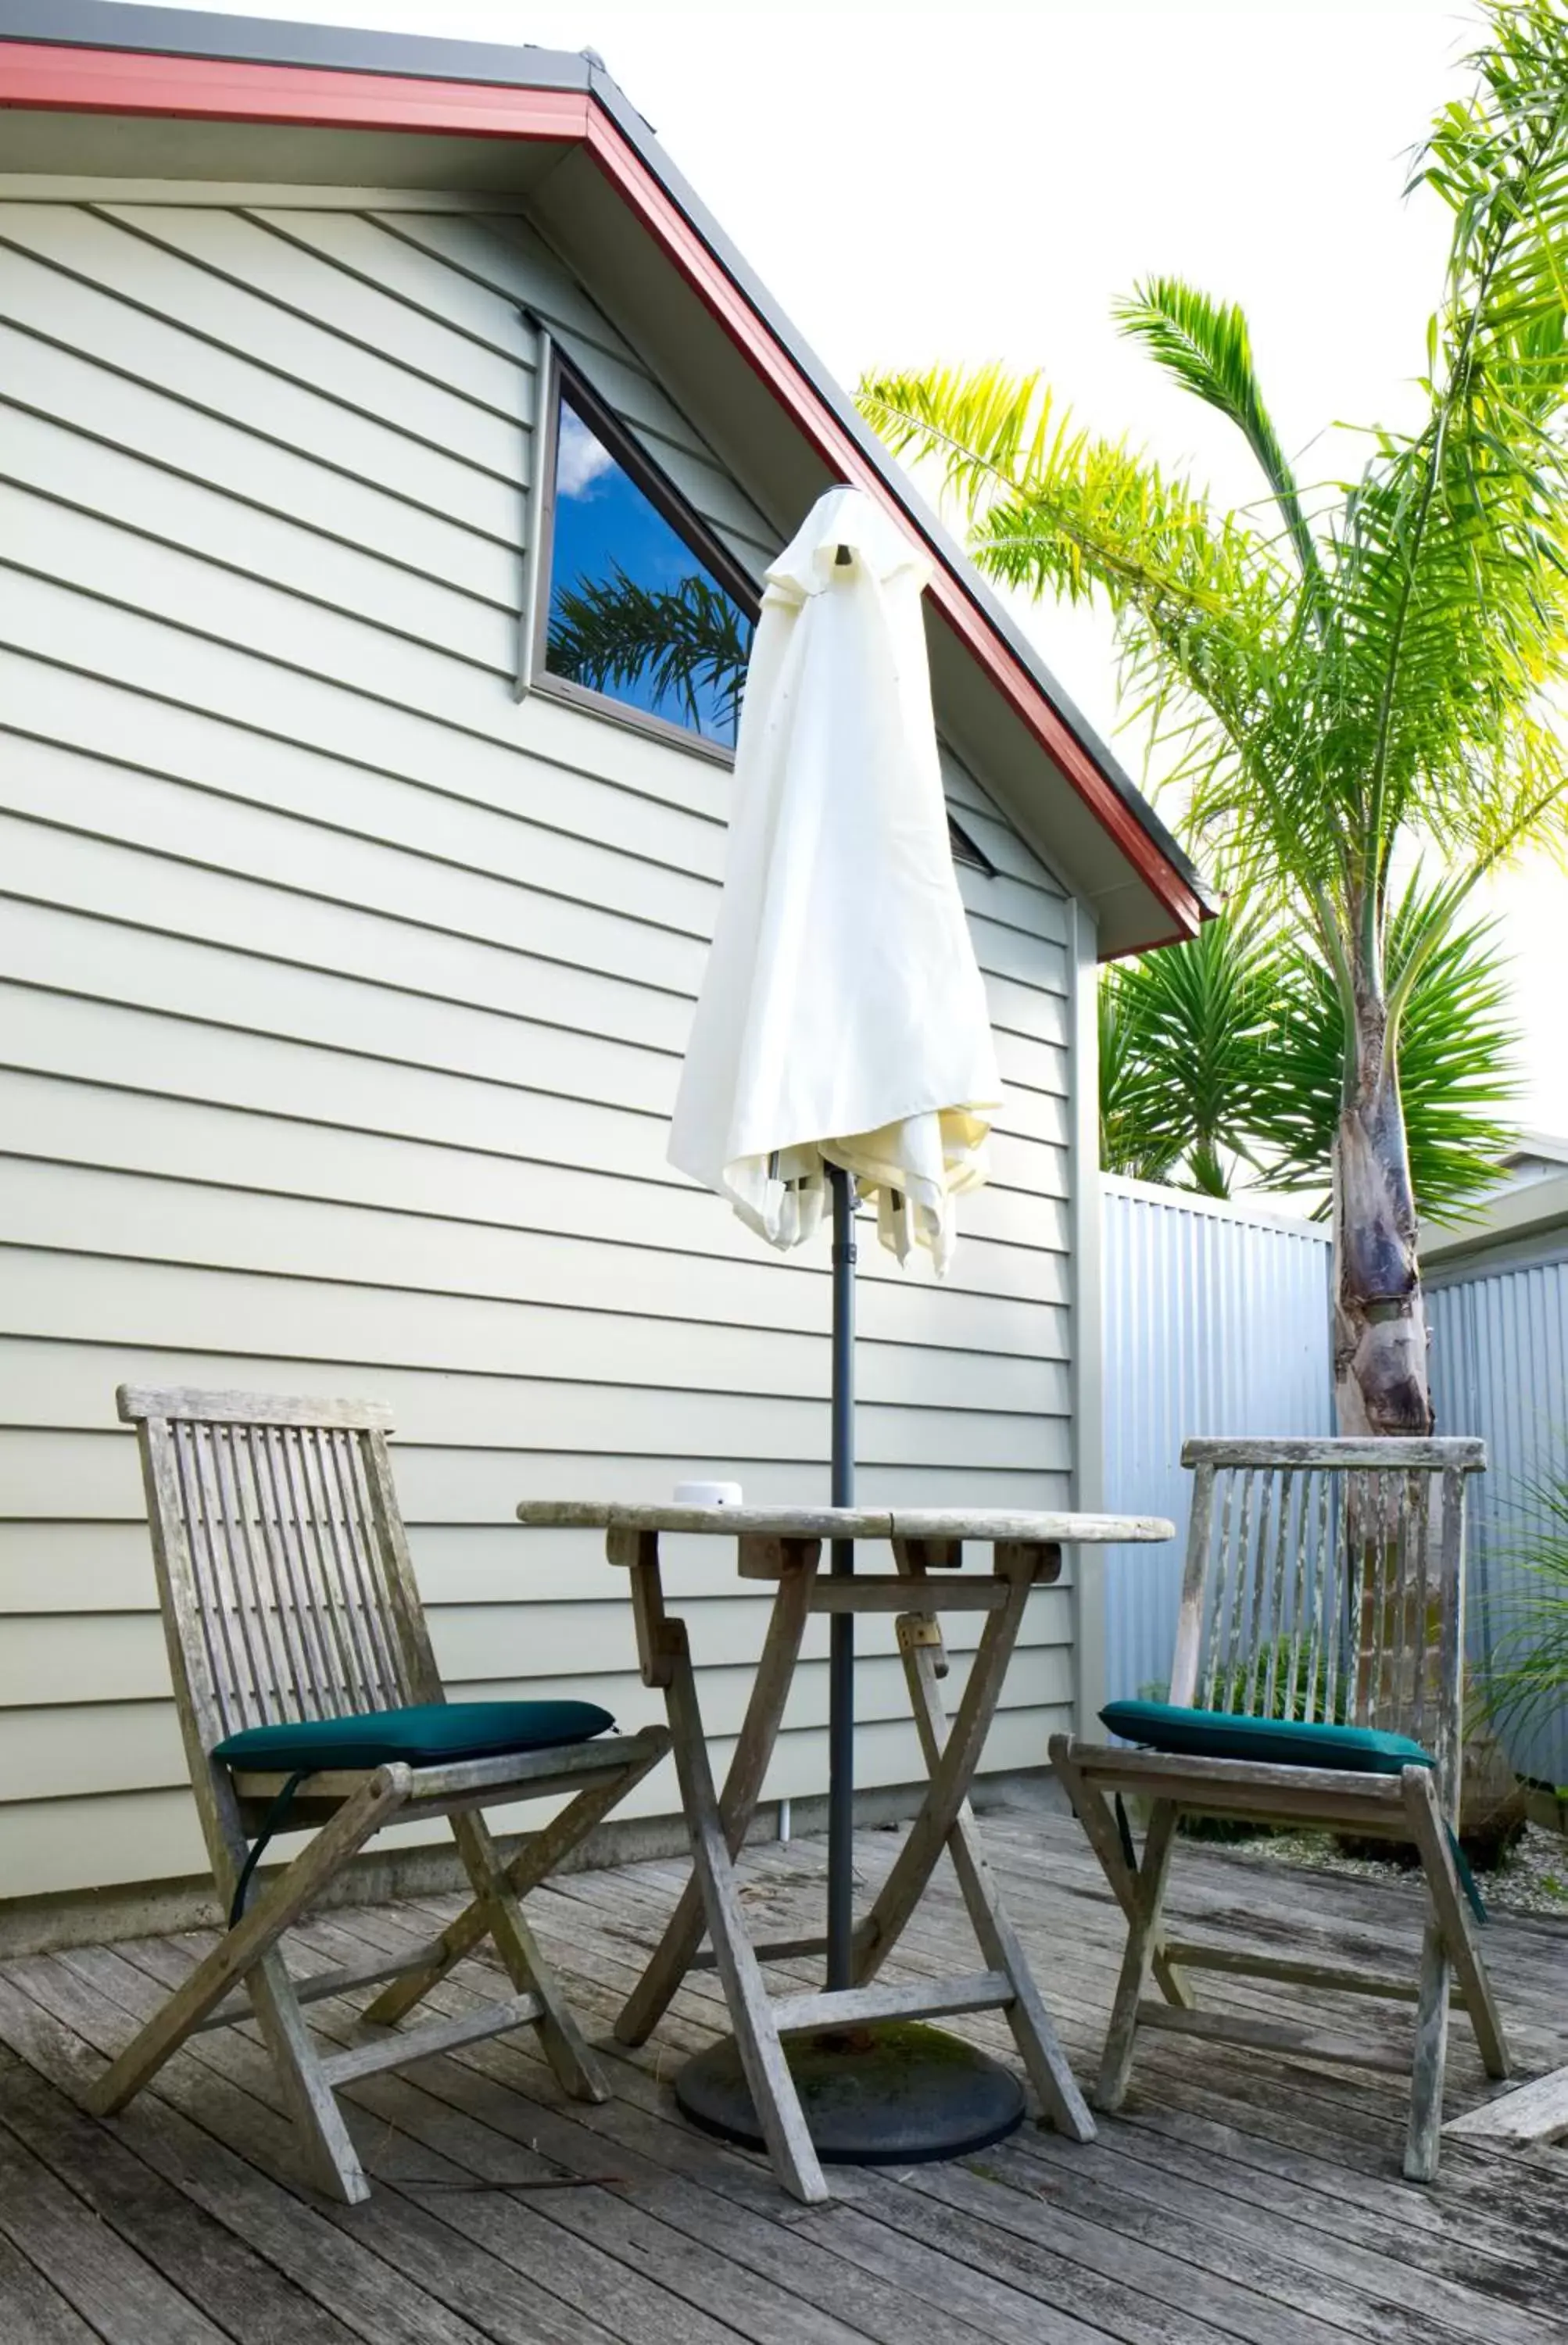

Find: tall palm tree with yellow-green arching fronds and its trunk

[860,0,1568,1433]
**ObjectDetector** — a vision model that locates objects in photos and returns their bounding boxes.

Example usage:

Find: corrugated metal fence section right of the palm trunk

[1427,1248,1568,1782]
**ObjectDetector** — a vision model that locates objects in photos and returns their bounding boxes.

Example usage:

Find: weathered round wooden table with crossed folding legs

[518,1498,1174,2202]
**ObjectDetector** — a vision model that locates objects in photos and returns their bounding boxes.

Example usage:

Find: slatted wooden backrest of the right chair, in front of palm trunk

[1169,1440,1486,1810]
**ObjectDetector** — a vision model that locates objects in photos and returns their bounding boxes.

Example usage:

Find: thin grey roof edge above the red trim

[0,0,1223,912]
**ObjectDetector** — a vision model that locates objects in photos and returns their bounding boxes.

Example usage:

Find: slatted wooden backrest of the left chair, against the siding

[115,1384,443,1759]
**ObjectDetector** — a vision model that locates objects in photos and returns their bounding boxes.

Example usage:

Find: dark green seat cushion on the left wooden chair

[213,1702,614,1775]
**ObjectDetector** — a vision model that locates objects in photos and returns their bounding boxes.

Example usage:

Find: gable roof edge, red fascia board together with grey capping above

[0,0,1214,936]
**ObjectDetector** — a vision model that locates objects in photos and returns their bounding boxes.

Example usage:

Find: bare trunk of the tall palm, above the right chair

[1334,985,1432,1435]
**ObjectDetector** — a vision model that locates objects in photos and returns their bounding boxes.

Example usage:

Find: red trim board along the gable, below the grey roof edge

[0,42,1202,936]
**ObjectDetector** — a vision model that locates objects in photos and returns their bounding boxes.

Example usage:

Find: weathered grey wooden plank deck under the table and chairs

[0,1815,1568,2345]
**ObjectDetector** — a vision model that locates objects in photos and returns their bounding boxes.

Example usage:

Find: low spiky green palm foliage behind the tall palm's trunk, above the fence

[1099,882,1519,1222]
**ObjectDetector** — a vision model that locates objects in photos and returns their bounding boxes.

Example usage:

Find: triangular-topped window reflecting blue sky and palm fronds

[535,363,757,750]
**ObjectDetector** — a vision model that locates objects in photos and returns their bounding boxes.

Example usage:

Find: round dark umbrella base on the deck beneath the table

[675,2021,1024,2167]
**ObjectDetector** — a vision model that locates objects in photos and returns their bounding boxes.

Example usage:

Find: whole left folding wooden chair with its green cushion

[91,1386,671,2202]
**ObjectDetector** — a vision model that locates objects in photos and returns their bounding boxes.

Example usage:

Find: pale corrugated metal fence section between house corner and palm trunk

[1104,1175,1334,1700]
